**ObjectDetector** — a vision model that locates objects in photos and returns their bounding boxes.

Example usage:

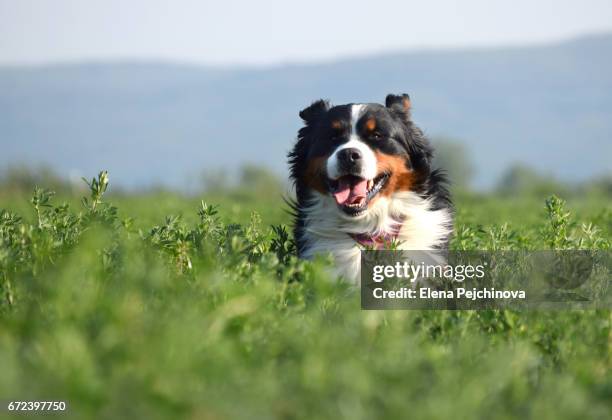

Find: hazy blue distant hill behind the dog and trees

[0,35,612,186]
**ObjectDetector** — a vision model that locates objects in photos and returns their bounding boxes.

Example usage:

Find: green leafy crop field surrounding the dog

[0,172,612,419]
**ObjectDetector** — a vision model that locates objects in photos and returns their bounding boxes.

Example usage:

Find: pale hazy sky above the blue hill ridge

[0,0,612,65]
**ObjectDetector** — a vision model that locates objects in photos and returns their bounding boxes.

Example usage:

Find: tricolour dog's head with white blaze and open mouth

[289,94,432,217]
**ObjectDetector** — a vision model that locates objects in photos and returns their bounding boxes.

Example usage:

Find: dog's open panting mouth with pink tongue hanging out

[327,172,391,216]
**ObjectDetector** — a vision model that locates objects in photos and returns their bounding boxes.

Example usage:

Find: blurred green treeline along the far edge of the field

[0,155,612,198]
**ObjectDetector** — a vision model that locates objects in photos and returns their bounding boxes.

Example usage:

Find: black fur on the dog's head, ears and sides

[288,94,452,254]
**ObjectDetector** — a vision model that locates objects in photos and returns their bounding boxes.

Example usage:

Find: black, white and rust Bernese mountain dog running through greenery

[288,94,453,284]
